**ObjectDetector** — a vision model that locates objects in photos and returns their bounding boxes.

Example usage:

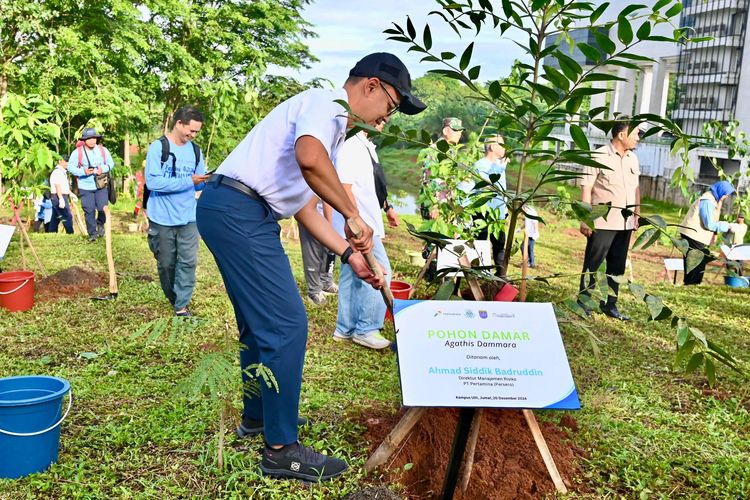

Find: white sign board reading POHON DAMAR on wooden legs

[395,300,581,409]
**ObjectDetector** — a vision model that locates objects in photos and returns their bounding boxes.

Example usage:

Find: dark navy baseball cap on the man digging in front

[349,52,427,115]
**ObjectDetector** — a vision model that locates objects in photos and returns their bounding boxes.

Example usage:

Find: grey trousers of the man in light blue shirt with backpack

[148,220,200,311]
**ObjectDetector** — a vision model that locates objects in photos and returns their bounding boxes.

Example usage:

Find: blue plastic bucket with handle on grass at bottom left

[0,376,73,479]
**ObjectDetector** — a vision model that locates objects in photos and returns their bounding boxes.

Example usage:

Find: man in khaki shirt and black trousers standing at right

[580,120,643,321]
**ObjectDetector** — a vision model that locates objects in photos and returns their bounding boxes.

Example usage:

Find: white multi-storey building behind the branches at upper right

[547,0,750,201]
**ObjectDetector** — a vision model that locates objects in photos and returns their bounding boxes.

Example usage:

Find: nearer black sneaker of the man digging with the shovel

[260,442,349,482]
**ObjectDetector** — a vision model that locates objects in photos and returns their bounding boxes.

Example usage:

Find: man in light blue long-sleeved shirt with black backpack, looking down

[144,106,208,316]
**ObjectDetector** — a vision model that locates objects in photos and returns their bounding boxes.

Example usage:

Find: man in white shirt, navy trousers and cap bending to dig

[196,52,426,482]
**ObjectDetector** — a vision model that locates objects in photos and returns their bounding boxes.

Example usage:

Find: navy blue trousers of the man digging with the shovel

[196,183,307,445]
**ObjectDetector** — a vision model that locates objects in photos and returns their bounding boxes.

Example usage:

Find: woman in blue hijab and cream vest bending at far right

[680,181,734,285]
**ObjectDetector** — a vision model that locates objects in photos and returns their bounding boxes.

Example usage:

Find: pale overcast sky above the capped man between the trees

[271,0,523,87]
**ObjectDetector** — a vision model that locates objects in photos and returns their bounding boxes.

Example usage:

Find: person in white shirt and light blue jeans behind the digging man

[333,122,391,349]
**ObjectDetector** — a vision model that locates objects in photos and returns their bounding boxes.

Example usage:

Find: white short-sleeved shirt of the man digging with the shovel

[216,89,347,219]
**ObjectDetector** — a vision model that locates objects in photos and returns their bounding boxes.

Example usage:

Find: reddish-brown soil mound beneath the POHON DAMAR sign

[365,408,577,500]
